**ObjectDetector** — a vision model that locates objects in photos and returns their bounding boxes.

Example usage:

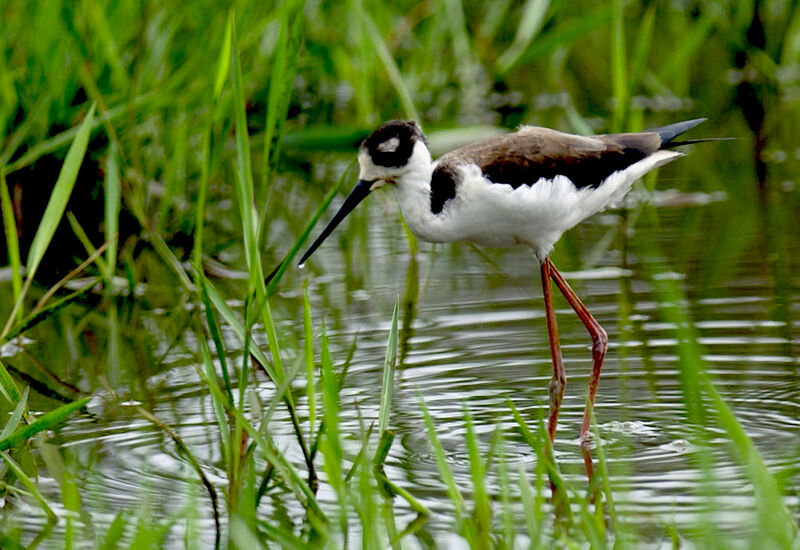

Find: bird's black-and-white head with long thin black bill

[300,120,431,265]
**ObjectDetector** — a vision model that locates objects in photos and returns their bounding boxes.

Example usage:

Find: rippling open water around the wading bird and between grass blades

[6,144,800,546]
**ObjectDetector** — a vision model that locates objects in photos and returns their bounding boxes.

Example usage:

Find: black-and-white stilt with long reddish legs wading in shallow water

[300,118,708,473]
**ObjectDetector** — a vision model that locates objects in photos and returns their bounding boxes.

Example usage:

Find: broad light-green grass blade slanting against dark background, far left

[26,105,95,279]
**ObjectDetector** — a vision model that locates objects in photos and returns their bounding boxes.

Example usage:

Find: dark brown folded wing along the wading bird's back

[434,127,662,189]
